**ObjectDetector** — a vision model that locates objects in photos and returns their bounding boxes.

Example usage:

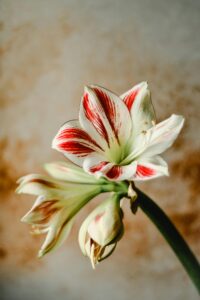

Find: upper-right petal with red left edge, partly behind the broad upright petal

[121,82,155,136]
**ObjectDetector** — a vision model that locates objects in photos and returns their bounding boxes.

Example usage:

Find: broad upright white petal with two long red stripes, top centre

[79,85,131,150]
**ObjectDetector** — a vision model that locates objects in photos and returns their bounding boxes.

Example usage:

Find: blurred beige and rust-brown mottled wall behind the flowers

[0,0,200,300]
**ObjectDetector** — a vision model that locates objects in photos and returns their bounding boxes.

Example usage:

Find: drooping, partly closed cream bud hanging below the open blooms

[79,194,124,268]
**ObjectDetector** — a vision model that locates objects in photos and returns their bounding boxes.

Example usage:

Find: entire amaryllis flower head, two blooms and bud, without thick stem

[17,82,184,267]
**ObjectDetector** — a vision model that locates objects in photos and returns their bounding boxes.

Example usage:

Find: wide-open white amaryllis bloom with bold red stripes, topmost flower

[52,82,184,181]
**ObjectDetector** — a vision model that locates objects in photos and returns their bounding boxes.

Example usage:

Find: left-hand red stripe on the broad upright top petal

[83,93,109,146]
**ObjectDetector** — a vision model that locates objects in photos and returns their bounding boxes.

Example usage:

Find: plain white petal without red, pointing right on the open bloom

[141,115,184,157]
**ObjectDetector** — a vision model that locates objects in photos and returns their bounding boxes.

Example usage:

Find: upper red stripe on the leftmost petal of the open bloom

[57,128,102,150]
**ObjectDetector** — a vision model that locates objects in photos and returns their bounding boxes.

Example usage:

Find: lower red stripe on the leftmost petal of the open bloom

[57,141,94,157]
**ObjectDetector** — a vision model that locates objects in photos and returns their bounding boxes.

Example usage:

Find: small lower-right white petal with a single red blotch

[132,156,169,181]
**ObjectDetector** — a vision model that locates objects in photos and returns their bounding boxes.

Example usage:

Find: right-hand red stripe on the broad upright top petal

[94,88,118,140]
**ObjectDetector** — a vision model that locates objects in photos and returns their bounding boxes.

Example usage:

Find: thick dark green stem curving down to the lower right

[134,188,200,294]
